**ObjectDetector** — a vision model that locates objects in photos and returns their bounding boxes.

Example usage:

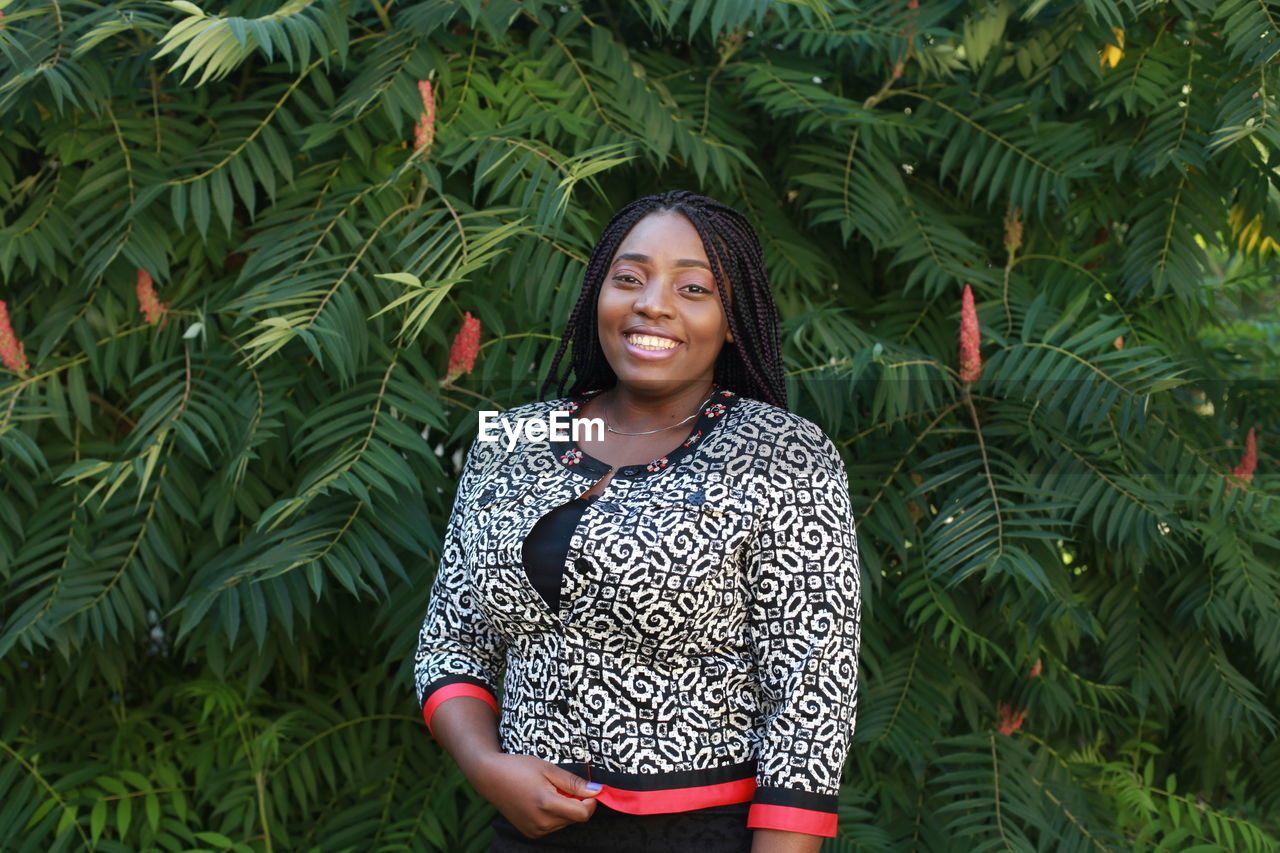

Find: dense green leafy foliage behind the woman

[0,0,1280,853]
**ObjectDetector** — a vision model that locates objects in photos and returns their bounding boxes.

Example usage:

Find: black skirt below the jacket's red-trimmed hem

[489,803,754,853]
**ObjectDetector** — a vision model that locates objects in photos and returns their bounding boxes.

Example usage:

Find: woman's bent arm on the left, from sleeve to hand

[415,427,599,836]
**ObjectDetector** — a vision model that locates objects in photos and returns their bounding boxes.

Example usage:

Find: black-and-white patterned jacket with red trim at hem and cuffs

[415,391,860,836]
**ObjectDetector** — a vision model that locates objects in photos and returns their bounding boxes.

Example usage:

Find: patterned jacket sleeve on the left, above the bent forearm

[413,427,506,730]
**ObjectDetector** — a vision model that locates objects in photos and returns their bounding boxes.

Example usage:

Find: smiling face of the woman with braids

[596,210,733,392]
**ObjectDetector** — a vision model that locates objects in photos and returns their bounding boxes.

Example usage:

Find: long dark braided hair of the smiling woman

[541,190,787,409]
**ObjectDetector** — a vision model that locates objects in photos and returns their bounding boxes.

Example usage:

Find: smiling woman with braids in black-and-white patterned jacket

[416,192,860,853]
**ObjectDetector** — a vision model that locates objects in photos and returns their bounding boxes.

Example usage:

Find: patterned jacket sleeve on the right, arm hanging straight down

[748,421,861,838]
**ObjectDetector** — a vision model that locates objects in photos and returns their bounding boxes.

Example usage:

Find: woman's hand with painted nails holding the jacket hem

[471,753,600,838]
